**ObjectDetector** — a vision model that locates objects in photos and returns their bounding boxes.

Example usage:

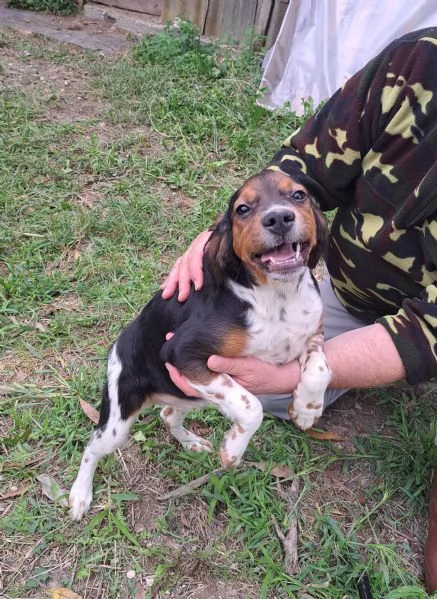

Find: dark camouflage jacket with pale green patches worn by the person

[269,27,437,384]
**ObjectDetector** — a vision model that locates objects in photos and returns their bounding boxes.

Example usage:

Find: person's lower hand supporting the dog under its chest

[166,356,300,397]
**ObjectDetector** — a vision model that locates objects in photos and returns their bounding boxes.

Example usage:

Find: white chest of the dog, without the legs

[228,271,322,364]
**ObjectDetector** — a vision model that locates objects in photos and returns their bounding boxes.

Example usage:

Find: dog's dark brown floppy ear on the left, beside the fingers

[205,210,233,285]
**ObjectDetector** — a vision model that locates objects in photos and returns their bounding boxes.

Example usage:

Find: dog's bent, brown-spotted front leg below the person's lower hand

[189,374,263,468]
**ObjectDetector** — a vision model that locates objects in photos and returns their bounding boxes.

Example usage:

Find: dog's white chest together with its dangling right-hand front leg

[230,268,331,430]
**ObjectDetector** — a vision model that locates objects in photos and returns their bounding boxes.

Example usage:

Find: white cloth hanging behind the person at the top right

[258,0,437,115]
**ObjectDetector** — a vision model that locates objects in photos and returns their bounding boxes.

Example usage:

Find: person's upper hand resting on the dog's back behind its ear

[162,231,211,302]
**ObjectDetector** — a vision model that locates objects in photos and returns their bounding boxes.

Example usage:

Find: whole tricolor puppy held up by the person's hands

[70,170,330,520]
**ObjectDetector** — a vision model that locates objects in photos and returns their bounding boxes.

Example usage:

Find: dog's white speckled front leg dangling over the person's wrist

[288,331,331,430]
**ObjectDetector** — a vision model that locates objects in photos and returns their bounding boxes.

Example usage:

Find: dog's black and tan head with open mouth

[206,170,328,285]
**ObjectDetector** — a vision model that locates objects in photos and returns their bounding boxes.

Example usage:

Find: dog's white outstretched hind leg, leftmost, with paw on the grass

[69,346,139,520]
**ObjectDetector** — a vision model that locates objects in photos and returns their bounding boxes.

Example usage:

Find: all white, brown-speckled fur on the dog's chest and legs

[69,269,330,520]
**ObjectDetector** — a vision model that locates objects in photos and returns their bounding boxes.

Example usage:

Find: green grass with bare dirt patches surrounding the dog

[0,25,436,599]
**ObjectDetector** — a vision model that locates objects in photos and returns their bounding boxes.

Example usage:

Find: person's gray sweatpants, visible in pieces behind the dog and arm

[259,274,366,420]
